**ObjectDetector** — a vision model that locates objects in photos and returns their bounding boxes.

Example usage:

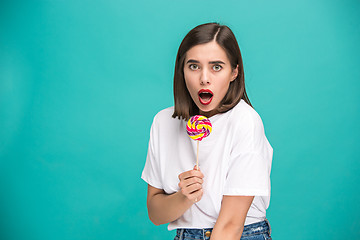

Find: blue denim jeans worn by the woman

[174,219,271,240]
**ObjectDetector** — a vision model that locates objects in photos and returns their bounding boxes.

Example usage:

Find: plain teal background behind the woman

[0,0,360,240]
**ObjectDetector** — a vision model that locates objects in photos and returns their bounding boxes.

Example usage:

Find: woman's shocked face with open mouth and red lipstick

[184,41,238,117]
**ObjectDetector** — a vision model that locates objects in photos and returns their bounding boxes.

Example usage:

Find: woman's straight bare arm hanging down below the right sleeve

[211,196,254,240]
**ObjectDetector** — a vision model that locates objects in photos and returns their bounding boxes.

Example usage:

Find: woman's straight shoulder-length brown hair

[172,23,252,120]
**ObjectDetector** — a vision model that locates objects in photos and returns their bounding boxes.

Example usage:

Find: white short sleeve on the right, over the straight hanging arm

[223,109,273,196]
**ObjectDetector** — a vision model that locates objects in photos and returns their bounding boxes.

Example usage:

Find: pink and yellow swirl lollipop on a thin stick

[186,115,212,170]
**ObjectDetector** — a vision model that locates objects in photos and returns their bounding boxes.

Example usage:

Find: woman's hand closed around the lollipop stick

[179,166,204,203]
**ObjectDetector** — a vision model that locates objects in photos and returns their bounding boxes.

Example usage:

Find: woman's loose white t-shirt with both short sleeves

[141,100,273,230]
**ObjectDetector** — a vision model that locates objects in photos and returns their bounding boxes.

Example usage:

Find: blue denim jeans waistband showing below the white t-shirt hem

[176,219,271,240]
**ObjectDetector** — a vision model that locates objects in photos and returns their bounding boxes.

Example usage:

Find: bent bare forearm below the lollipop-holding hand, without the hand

[148,192,193,225]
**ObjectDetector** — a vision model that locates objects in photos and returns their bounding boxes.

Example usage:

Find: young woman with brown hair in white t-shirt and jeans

[142,23,273,240]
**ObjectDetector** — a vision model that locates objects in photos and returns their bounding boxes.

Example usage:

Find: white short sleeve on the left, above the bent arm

[141,117,163,189]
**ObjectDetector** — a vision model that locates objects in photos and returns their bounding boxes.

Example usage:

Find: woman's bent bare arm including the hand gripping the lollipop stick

[147,167,204,225]
